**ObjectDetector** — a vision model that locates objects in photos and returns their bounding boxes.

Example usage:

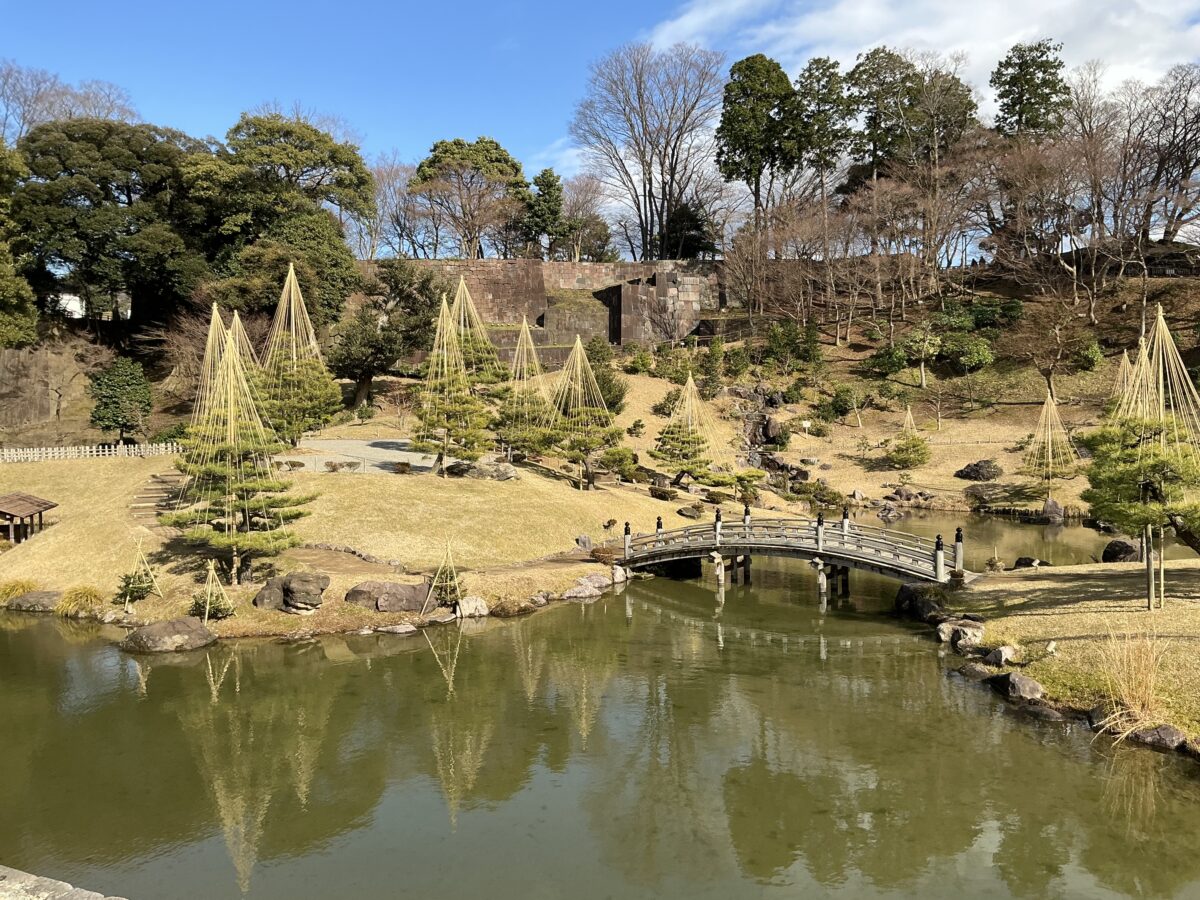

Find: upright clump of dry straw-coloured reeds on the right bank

[1097,629,1170,744]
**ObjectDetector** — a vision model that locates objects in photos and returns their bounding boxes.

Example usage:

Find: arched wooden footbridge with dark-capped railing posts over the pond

[623,512,964,582]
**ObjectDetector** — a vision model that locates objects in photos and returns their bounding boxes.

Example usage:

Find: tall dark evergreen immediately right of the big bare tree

[716,53,793,234]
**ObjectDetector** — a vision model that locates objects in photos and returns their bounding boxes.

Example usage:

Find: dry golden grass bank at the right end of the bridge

[954,559,1200,734]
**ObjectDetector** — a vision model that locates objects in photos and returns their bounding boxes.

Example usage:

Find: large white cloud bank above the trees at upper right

[650,0,1200,102]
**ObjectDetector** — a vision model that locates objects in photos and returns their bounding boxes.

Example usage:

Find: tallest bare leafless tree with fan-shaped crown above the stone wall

[570,43,725,259]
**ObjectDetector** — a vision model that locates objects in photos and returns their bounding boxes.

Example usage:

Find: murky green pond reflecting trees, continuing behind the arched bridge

[0,518,1200,900]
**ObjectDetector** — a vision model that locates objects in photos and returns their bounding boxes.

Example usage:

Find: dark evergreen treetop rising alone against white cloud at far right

[989,38,1070,137]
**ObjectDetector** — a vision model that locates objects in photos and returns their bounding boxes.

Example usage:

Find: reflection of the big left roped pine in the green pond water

[176,646,341,893]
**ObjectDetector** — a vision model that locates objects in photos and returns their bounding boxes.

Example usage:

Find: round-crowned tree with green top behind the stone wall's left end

[408,137,528,259]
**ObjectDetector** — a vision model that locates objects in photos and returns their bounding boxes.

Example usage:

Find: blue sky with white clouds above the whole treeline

[0,0,1200,174]
